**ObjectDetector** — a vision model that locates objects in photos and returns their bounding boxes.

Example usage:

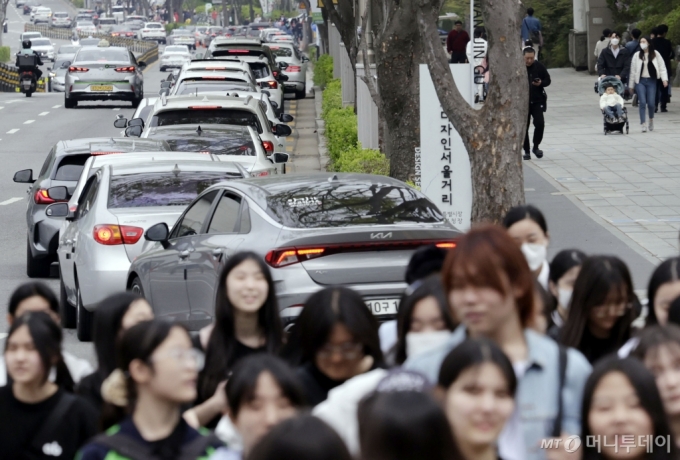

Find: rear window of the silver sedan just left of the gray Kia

[108,168,241,209]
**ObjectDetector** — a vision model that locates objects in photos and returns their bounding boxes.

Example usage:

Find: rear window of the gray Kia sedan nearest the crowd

[266,182,444,228]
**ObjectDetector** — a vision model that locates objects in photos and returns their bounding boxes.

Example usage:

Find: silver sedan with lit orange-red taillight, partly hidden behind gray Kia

[45,158,244,341]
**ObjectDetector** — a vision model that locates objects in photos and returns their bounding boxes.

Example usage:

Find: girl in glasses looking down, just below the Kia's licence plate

[286,287,383,406]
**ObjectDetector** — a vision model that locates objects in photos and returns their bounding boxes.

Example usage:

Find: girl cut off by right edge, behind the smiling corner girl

[633,324,680,446]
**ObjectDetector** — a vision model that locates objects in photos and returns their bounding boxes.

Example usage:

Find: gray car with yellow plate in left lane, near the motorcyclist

[64,46,146,109]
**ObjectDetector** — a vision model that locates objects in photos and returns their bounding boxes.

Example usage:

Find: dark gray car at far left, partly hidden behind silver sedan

[14,137,171,278]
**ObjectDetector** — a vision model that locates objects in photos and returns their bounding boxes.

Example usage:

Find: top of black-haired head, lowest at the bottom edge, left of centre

[247,415,352,460]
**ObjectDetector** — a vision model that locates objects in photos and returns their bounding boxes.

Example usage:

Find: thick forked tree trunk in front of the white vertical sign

[414,0,529,223]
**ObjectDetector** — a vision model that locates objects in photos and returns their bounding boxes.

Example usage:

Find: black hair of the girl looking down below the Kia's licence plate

[285,286,383,366]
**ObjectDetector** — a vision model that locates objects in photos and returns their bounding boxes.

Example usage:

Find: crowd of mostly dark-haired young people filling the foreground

[6,205,680,460]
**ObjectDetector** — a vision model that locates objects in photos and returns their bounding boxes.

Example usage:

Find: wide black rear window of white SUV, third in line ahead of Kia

[151,109,262,133]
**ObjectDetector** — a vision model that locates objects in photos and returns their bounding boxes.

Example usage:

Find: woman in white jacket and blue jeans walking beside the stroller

[628,37,668,133]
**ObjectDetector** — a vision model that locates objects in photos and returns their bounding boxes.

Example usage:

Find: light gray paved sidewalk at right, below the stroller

[524,69,680,264]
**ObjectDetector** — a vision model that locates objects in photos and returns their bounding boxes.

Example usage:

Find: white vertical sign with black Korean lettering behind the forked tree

[416,64,474,231]
